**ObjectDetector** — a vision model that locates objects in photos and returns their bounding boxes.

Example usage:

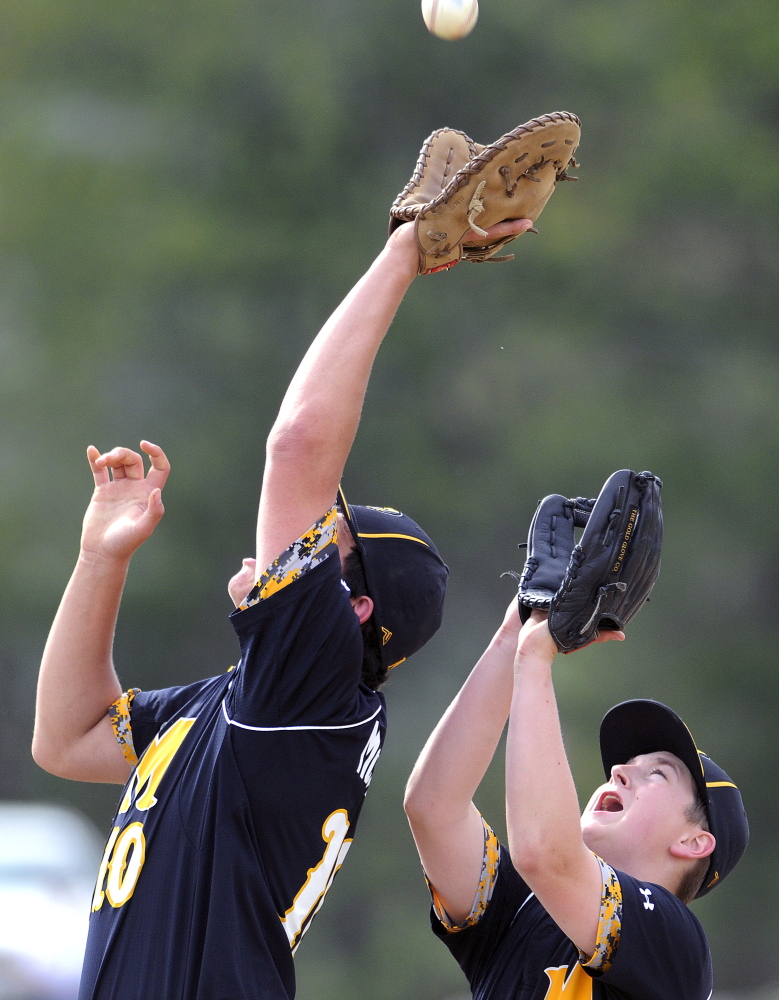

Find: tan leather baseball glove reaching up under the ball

[389,111,581,274]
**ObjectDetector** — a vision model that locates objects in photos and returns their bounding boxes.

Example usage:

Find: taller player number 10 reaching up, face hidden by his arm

[33,213,531,1000]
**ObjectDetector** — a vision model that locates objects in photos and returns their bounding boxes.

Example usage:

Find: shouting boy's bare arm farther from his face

[404,601,520,924]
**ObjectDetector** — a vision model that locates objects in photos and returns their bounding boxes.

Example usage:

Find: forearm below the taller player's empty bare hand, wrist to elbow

[33,554,129,777]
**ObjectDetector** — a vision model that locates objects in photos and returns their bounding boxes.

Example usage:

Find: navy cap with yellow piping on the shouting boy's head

[600,699,749,899]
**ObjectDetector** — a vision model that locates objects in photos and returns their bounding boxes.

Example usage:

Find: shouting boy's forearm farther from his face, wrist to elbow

[404,623,517,828]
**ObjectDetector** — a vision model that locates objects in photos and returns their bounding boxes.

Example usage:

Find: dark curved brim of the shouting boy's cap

[600,698,708,802]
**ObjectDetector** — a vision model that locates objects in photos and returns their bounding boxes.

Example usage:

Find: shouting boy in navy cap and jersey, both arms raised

[405,601,748,1000]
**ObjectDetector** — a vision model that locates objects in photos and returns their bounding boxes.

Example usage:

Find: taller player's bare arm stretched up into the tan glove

[257,220,532,573]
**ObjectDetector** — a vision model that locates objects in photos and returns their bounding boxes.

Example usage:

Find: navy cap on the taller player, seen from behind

[338,488,449,669]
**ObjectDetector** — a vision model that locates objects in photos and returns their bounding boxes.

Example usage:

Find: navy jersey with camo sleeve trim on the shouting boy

[432,846,712,1000]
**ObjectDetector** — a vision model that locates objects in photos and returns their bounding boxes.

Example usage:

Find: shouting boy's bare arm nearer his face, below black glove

[506,611,624,956]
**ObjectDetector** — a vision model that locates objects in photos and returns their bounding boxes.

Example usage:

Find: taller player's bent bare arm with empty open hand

[32,441,170,784]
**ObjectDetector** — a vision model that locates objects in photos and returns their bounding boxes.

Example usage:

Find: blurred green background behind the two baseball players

[0,0,779,1000]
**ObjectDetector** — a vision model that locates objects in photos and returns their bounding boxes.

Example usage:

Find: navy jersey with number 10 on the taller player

[80,552,385,1000]
